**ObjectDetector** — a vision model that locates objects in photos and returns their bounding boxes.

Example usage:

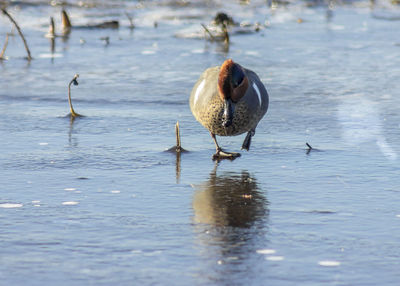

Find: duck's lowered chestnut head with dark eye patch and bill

[218,59,249,127]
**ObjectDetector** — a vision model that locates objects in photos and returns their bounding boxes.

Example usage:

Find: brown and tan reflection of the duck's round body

[193,165,268,228]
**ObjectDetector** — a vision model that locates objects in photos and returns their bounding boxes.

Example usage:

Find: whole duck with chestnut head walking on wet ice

[189,59,269,160]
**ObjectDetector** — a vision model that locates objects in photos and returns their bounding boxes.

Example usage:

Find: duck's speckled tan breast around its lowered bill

[195,97,260,136]
